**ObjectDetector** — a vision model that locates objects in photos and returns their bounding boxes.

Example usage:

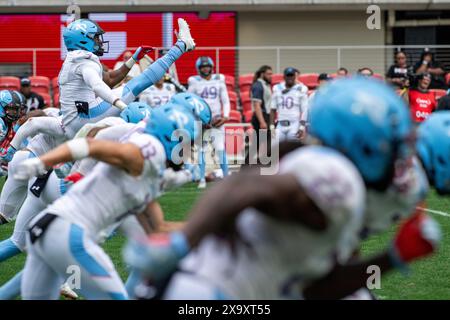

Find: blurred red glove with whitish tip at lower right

[389,212,442,271]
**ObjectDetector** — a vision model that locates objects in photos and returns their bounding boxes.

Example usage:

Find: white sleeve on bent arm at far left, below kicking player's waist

[11,117,65,149]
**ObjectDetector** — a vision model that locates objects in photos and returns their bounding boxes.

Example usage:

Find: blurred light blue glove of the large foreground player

[123,232,189,282]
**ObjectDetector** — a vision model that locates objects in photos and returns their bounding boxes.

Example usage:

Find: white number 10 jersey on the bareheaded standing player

[271,82,308,121]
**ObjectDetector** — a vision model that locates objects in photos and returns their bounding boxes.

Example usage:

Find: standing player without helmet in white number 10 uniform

[270,68,308,141]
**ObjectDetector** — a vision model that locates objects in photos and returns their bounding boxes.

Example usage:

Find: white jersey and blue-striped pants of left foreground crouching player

[22,132,166,299]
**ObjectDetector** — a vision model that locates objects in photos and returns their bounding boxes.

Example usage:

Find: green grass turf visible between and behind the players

[0,180,450,300]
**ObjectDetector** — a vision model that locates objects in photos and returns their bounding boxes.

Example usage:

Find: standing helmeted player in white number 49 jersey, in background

[188,57,230,188]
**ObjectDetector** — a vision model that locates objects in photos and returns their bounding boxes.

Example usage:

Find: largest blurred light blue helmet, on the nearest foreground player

[309,77,414,190]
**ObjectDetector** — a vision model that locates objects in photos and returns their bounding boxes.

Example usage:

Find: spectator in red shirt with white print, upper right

[408,73,437,123]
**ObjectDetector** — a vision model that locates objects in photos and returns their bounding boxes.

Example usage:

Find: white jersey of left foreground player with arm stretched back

[48,132,166,238]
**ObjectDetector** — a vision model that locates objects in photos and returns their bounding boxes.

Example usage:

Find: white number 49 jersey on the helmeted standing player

[188,74,230,118]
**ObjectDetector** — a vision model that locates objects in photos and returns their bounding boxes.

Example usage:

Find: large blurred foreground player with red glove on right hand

[125,79,439,299]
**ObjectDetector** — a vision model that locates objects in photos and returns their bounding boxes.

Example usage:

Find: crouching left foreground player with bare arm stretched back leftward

[11,106,197,299]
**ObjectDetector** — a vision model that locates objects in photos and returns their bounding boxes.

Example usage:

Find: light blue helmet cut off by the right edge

[416,111,450,194]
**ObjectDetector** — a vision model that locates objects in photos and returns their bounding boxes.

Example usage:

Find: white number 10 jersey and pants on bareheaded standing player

[271,82,308,141]
